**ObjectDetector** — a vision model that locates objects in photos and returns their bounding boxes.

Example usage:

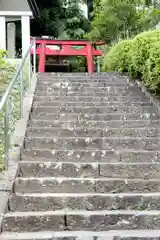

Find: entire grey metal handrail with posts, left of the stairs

[0,38,36,169]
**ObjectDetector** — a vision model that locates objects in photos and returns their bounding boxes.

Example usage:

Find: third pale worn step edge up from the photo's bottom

[10,192,160,198]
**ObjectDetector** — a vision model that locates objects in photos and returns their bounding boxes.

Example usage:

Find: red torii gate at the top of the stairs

[31,39,104,73]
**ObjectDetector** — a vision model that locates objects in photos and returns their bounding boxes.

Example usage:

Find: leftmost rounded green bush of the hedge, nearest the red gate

[103,39,132,72]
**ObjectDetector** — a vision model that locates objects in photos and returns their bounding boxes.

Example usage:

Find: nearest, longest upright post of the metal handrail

[4,98,9,169]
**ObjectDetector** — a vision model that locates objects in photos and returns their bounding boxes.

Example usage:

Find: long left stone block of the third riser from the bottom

[14,178,96,193]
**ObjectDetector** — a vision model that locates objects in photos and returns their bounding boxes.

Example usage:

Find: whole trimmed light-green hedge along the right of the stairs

[103,30,160,93]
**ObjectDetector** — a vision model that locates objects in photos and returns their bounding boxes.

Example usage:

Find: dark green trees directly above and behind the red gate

[31,0,90,39]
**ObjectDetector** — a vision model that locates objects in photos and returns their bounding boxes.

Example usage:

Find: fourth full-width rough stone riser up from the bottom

[19,161,160,179]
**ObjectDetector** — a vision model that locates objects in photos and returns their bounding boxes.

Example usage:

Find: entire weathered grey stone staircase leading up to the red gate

[0,73,160,240]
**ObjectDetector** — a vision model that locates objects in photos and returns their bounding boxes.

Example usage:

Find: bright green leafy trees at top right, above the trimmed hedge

[88,0,160,44]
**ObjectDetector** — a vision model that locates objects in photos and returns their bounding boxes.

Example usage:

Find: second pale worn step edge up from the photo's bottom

[5,209,160,218]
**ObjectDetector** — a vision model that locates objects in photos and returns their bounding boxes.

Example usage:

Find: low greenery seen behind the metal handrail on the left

[0,59,28,170]
